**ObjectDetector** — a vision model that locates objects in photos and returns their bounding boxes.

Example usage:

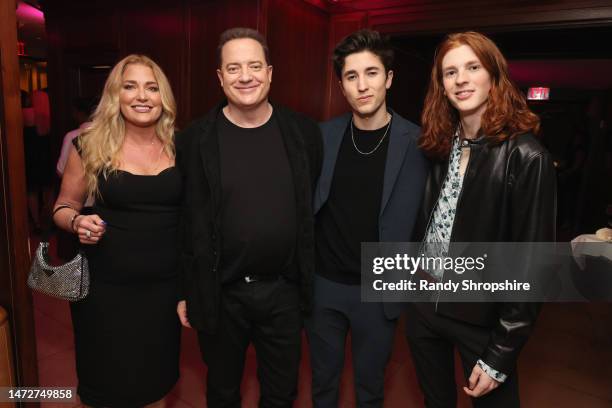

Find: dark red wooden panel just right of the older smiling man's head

[268,0,329,120]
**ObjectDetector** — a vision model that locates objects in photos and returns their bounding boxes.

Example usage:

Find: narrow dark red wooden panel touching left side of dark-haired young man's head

[325,13,367,119]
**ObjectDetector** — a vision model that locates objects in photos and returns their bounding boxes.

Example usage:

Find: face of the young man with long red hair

[442,45,491,117]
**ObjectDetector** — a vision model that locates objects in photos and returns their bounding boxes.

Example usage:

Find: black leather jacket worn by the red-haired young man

[415,134,556,373]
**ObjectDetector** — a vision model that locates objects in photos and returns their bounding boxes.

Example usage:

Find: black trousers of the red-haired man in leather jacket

[406,303,520,408]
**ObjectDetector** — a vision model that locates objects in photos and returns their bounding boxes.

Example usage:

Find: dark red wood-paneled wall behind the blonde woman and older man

[44,0,329,143]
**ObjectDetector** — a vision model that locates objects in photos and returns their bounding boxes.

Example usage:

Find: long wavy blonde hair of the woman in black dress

[78,54,176,197]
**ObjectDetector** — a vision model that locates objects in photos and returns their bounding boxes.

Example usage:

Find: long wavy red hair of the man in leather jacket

[419,31,540,159]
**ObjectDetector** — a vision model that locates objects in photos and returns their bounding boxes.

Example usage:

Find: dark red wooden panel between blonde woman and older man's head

[187,0,259,120]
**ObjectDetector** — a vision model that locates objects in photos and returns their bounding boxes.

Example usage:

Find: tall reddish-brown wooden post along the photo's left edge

[0,0,38,392]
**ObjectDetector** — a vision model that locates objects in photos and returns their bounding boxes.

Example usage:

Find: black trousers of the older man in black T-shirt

[198,278,302,408]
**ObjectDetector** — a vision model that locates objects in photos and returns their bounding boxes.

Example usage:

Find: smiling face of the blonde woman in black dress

[119,64,162,127]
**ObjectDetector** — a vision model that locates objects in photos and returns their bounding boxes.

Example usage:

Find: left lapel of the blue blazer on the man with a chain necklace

[314,114,350,214]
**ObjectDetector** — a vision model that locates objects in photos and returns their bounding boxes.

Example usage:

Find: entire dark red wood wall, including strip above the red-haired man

[42,0,612,139]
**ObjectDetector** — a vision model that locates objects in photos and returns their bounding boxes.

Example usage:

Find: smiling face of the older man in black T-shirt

[217,38,272,110]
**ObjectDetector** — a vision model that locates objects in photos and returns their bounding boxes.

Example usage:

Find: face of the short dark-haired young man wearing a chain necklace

[340,51,393,117]
